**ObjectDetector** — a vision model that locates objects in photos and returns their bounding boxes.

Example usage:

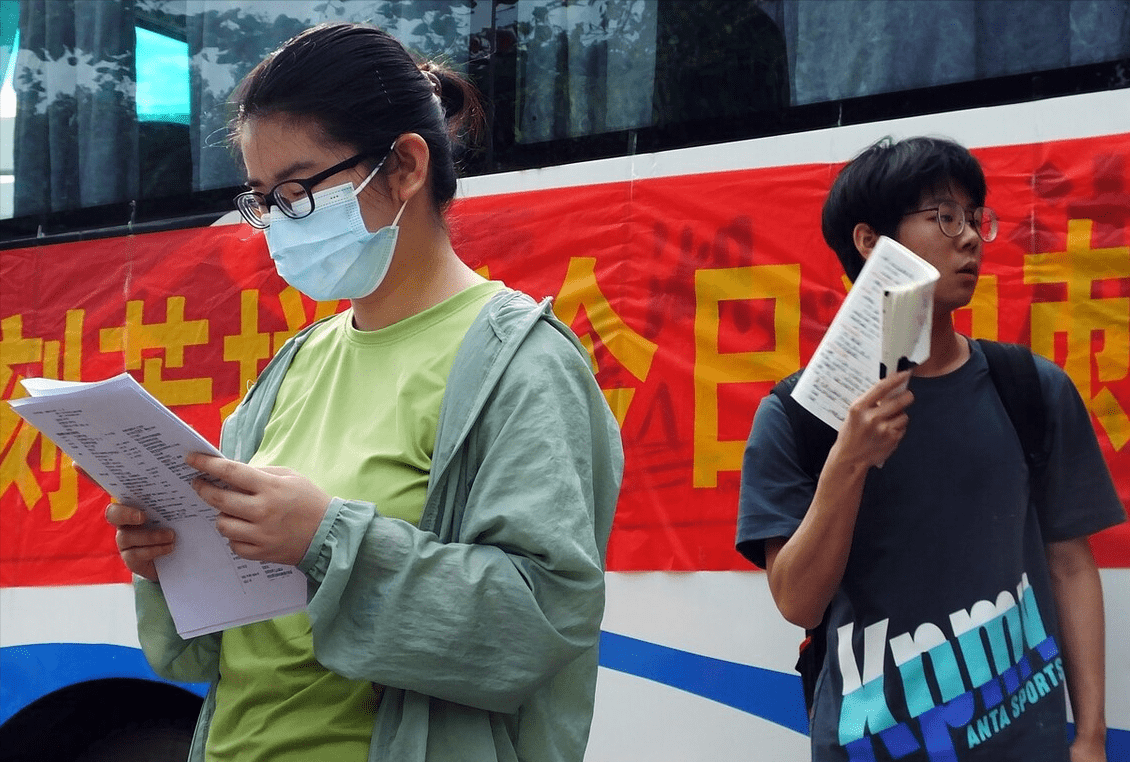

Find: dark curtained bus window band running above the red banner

[0,0,1130,242]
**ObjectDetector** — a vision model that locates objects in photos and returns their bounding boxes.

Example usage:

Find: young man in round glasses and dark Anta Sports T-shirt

[738,138,1124,762]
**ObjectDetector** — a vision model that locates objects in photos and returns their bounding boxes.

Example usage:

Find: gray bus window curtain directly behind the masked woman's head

[185,0,473,190]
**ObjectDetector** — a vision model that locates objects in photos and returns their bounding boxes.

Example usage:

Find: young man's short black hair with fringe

[820,137,988,282]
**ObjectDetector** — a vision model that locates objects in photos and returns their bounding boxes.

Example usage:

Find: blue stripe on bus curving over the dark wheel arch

[0,643,208,724]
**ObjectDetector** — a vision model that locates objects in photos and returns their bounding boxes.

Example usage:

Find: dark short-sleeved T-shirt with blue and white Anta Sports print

[738,344,1124,762]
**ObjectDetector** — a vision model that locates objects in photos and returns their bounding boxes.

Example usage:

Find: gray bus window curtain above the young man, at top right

[782,0,1130,105]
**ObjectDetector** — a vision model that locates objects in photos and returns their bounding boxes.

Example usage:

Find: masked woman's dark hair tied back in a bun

[232,24,483,211]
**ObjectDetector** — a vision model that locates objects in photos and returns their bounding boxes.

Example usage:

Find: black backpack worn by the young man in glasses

[763,339,1048,715]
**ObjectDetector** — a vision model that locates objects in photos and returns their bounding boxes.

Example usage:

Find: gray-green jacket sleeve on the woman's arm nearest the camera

[299,327,623,712]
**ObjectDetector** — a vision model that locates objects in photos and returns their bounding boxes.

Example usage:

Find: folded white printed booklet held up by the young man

[792,236,939,431]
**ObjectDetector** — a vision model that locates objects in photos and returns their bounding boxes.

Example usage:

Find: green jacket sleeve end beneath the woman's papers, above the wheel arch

[133,578,219,683]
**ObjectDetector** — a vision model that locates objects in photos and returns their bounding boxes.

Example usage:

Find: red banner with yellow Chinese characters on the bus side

[0,135,1130,586]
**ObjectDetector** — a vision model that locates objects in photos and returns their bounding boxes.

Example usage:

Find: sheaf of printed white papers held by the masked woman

[9,373,306,638]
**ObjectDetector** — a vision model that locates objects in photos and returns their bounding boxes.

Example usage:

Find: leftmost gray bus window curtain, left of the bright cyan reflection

[14,0,138,214]
